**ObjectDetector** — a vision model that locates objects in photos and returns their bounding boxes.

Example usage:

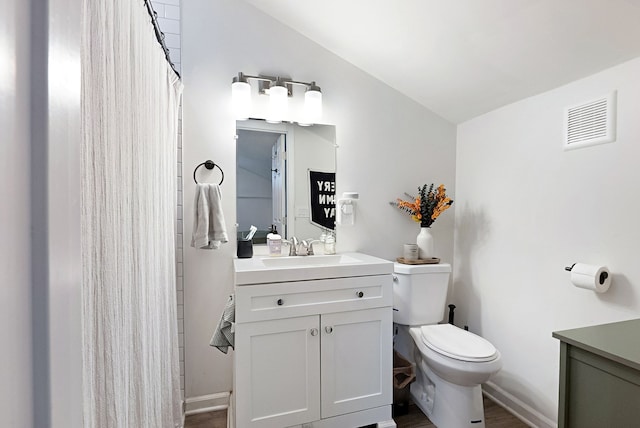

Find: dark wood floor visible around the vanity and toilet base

[185,398,527,428]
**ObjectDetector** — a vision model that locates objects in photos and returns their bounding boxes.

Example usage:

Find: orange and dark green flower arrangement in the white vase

[390,183,453,227]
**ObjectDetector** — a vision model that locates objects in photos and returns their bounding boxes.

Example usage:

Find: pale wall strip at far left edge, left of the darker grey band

[0,0,33,427]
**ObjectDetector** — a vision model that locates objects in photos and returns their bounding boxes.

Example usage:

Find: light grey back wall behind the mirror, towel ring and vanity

[182,0,456,401]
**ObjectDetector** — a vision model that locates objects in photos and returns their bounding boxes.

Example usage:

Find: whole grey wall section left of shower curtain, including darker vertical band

[0,0,82,427]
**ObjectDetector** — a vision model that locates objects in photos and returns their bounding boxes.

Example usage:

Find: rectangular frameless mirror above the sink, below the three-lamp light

[236,119,337,244]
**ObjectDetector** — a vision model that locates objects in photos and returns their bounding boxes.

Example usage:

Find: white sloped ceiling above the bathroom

[245,0,640,123]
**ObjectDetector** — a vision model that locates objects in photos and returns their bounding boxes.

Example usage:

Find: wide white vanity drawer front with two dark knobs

[235,275,393,323]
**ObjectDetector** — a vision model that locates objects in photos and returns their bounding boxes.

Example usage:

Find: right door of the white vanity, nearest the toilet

[320,307,393,418]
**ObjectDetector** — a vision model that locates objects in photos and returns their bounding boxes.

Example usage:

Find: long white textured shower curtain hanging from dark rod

[82,0,183,428]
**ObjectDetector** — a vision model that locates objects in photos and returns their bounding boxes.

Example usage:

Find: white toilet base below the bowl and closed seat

[411,351,485,428]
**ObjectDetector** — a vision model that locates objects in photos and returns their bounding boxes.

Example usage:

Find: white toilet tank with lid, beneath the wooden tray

[393,263,451,325]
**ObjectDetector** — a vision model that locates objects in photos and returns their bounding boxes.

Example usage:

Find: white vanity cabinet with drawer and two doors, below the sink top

[232,274,395,428]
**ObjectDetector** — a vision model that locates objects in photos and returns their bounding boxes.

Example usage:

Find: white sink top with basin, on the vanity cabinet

[233,253,393,285]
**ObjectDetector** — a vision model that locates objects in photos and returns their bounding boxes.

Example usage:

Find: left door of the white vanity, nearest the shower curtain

[234,315,321,428]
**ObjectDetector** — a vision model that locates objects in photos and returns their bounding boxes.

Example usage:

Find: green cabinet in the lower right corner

[553,320,640,428]
